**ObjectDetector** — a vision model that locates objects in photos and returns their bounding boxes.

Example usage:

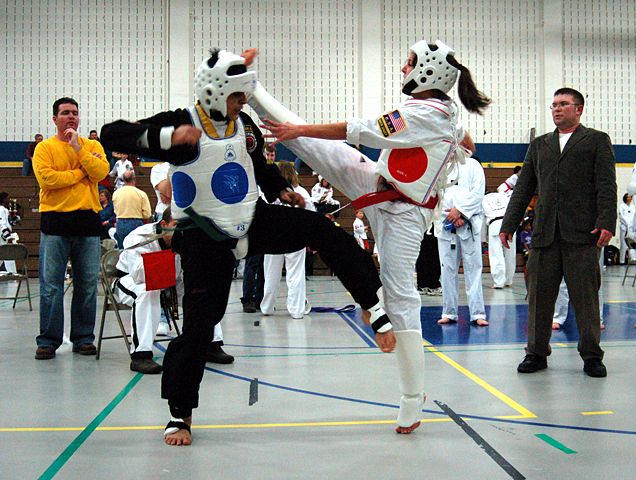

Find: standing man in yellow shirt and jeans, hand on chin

[33,97,108,360]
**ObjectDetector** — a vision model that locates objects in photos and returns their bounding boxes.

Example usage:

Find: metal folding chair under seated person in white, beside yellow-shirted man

[96,249,181,360]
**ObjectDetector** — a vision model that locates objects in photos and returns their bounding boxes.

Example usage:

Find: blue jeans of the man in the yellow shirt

[36,233,100,348]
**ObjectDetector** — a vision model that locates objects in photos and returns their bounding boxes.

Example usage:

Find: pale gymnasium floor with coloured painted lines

[0,266,636,480]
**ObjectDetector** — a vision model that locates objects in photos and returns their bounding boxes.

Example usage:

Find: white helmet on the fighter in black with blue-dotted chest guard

[194,50,256,117]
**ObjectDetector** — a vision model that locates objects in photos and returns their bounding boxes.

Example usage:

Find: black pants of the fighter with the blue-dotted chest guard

[161,200,381,418]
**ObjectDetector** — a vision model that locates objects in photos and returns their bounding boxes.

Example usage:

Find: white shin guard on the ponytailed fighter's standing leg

[395,330,426,427]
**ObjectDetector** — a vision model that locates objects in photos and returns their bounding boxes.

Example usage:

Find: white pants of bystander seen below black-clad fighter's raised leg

[261,248,307,318]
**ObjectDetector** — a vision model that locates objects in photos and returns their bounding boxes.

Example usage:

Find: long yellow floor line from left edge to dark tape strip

[0,418,452,433]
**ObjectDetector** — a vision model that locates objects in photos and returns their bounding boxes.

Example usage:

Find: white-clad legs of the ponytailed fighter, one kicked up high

[250,85,433,427]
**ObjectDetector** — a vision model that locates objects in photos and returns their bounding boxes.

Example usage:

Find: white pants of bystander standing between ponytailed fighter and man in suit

[437,233,486,322]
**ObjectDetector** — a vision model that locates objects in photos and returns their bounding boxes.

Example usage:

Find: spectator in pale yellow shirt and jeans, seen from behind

[113,170,151,248]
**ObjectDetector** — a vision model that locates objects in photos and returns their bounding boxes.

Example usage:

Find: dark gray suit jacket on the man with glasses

[501,125,616,248]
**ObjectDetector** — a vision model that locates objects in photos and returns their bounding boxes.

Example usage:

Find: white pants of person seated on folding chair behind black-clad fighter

[115,275,161,354]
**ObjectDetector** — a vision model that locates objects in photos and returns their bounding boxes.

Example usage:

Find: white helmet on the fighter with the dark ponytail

[402,40,459,95]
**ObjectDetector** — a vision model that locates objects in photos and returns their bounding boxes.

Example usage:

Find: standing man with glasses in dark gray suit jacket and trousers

[499,88,617,377]
